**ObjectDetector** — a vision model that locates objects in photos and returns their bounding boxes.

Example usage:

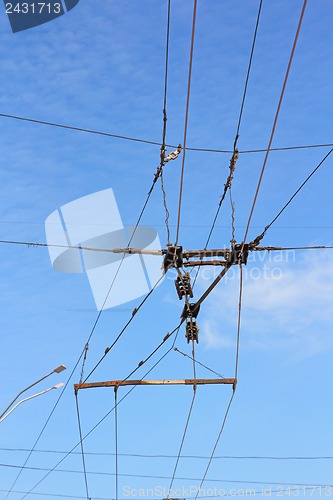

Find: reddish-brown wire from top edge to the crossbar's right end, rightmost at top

[243,0,307,245]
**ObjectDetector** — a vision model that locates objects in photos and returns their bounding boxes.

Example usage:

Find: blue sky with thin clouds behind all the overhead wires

[0,0,333,500]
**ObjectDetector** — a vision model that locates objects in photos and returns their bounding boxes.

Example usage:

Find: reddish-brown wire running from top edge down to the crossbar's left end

[175,0,197,246]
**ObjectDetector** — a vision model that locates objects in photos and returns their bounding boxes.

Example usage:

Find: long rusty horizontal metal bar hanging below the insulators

[74,378,237,391]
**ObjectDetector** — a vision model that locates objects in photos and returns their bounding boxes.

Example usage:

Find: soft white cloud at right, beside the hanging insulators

[198,250,333,357]
